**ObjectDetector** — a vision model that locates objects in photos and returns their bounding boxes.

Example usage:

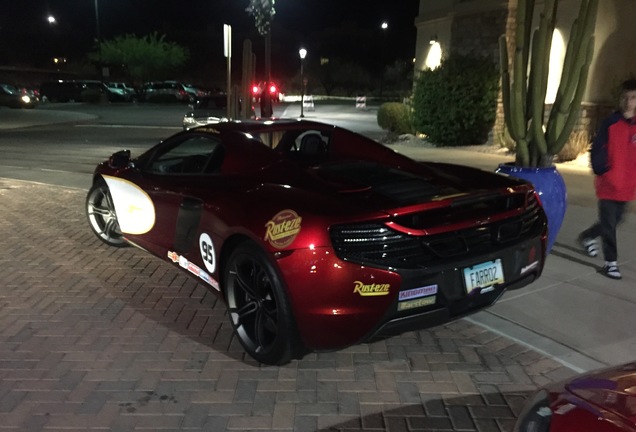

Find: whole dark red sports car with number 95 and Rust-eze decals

[86,120,547,364]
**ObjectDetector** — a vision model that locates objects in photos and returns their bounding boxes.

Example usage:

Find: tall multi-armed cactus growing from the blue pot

[499,0,598,167]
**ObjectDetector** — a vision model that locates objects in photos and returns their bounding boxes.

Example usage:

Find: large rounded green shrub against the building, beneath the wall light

[413,54,499,146]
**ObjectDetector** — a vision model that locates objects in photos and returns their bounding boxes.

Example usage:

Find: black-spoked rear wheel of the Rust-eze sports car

[223,242,303,365]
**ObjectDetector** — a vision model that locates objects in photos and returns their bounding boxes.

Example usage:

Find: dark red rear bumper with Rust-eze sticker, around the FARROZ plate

[281,236,545,350]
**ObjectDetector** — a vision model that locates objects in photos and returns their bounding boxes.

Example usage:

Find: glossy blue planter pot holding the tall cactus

[496,163,567,253]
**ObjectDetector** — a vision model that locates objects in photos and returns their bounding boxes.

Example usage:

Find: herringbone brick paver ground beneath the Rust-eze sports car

[0,179,573,432]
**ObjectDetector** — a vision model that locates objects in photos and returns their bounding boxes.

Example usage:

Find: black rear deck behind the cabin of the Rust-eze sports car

[309,161,520,209]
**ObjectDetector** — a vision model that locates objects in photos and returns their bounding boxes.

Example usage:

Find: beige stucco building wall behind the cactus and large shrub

[415,0,636,145]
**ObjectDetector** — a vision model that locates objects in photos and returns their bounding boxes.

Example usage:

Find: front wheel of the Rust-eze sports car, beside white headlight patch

[86,182,128,247]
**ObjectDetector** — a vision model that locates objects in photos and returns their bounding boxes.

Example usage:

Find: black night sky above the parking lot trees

[0,0,419,82]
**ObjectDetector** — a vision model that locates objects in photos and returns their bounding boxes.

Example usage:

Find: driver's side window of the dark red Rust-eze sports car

[146,135,224,175]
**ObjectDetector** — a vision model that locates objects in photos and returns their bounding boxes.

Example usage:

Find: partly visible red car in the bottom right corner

[515,363,636,432]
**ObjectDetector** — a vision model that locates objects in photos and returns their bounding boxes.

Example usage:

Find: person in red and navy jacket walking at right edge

[578,79,636,279]
